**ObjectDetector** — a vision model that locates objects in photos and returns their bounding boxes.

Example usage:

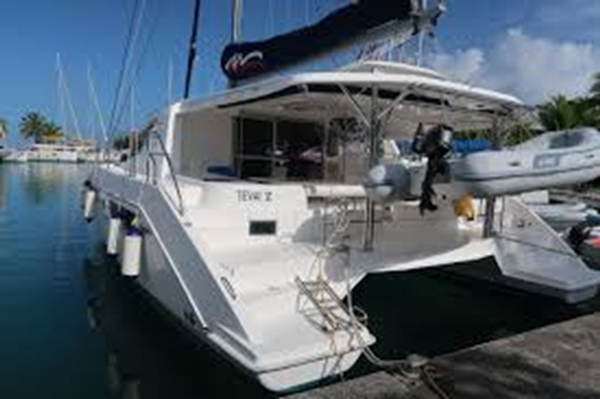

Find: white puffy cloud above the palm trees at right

[429,28,600,104]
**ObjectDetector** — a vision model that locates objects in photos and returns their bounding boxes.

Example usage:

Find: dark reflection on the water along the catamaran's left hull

[84,248,269,399]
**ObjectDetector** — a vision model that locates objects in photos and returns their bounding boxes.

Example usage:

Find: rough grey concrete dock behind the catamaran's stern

[287,313,600,399]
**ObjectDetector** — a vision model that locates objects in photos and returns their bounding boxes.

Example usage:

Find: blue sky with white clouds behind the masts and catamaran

[0,0,600,146]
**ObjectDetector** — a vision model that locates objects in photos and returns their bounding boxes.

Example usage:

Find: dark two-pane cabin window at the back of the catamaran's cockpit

[234,118,325,181]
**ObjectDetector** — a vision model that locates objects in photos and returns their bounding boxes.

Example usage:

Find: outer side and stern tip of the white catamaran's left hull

[92,169,374,392]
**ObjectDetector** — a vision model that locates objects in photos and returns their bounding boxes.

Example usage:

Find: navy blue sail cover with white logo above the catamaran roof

[221,0,416,81]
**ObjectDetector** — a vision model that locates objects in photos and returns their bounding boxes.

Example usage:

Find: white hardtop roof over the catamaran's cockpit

[175,62,529,135]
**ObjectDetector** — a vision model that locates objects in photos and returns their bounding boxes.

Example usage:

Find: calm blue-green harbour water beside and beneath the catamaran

[0,164,598,399]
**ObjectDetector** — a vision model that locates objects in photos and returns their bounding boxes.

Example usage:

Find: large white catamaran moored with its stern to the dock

[85,0,600,391]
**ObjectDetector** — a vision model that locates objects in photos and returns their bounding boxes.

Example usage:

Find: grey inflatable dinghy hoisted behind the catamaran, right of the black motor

[451,128,600,197]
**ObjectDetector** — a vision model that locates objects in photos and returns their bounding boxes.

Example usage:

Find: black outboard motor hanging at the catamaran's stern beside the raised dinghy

[413,124,454,215]
